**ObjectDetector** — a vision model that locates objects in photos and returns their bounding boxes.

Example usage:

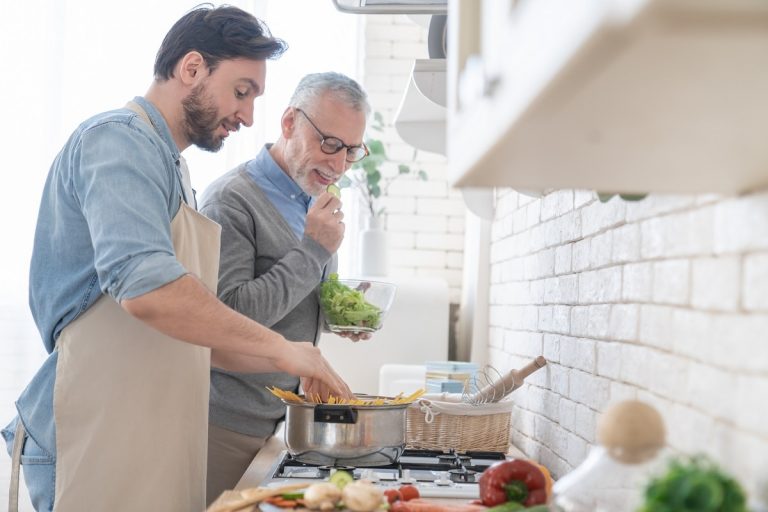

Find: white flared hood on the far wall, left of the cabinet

[394,59,446,155]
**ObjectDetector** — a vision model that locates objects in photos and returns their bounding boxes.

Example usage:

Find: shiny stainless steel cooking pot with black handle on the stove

[285,402,408,467]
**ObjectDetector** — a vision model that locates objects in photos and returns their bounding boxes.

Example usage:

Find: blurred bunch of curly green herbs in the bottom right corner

[638,455,747,512]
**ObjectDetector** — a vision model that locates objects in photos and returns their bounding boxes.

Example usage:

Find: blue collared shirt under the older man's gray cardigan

[245,144,314,240]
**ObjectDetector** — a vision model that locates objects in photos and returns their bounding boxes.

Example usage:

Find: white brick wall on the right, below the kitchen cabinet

[490,190,768,504]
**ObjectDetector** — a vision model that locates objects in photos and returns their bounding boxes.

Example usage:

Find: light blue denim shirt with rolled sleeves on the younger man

[3,97,190,484]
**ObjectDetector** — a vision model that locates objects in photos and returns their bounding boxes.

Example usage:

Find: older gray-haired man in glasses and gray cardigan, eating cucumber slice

[201,73,370,500]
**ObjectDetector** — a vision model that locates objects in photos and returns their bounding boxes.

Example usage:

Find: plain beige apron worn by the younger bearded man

[53,104,221,512]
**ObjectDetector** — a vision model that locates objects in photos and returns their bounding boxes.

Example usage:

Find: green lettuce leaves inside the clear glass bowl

[320,273,381,329]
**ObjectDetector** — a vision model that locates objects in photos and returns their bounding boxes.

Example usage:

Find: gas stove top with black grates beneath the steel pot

[263,449,505,499]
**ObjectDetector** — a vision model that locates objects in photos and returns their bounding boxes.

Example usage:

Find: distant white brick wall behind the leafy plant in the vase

[363,15,468,303]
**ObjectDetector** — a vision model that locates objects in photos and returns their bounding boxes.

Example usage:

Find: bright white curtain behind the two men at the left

[0,0,361,307]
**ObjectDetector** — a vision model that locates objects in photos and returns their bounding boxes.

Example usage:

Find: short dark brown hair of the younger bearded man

[155,4,288,81]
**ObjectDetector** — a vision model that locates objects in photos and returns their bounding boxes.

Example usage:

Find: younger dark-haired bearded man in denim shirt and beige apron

[3,6,349,512]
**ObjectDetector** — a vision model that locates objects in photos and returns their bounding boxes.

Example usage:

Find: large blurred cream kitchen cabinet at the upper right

[447,0,768,193]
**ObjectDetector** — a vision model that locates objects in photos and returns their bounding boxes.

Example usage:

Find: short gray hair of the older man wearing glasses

[289,71,371,117]
